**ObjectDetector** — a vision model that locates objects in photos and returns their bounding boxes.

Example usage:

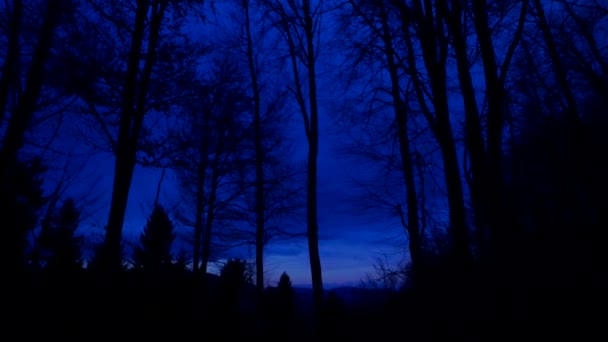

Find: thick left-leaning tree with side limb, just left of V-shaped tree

[397,0,472,265]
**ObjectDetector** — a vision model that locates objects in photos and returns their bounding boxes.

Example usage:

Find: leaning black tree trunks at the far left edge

[0,1,69,270]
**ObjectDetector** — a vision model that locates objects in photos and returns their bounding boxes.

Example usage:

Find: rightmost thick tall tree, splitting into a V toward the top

[444,1,528,259]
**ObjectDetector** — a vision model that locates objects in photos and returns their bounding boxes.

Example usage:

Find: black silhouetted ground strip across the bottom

[2,273,608,341]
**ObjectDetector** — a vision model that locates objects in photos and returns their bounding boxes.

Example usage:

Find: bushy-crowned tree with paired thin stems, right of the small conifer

[172,55,251,273]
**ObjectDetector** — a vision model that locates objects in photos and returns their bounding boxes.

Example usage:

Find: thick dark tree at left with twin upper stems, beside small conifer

[78,0,204,270]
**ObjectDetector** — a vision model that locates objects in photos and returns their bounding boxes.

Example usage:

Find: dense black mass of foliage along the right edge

[501,95,608,329]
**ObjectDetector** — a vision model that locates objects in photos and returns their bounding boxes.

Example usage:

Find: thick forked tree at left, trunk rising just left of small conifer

[78,0,204,269]
